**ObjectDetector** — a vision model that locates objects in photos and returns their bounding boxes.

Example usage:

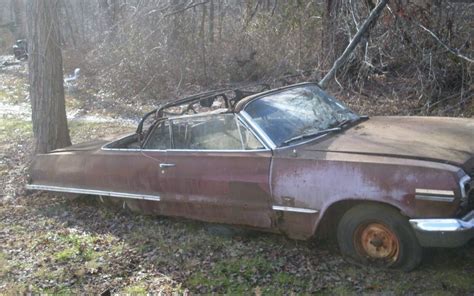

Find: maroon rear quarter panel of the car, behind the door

[30,143,166,195]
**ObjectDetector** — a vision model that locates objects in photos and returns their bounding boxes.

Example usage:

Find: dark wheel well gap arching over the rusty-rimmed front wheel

[315,200,400,241]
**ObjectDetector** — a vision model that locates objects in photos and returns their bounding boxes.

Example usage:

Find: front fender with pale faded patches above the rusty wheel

[271,144,460,237]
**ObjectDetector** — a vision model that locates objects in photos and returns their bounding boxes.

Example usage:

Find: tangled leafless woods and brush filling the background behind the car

[7,0,474,120]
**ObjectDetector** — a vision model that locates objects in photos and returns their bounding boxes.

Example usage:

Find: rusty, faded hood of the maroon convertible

[305,116,474,172]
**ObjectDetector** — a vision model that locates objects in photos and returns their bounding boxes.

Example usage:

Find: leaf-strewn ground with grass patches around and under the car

[0,57,474,295]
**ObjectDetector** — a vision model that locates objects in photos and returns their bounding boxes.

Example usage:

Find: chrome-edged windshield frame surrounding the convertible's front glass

[239,82,366,150]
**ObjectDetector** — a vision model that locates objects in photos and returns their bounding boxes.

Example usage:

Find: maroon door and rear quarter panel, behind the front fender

[30,142,273,228]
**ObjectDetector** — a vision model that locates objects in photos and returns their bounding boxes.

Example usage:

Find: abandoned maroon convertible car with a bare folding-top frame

[27,83,474,270]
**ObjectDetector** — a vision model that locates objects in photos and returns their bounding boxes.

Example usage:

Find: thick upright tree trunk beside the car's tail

[27,0,71,153]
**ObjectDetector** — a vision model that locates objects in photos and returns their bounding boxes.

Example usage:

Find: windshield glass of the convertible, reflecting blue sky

[244,85,359,146]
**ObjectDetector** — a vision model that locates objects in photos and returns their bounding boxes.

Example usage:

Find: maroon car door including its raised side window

[161,114,272,228]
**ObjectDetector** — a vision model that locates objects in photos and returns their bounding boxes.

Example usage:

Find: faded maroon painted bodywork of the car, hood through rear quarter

[30,113,474,238]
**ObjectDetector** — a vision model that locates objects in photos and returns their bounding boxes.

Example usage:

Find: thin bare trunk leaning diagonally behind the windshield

[319,0,388,88]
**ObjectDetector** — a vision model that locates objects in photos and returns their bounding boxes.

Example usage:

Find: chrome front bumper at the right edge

[410,211,474,248]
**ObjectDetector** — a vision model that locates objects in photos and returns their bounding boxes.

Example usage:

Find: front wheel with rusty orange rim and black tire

[337,204,422,271]
